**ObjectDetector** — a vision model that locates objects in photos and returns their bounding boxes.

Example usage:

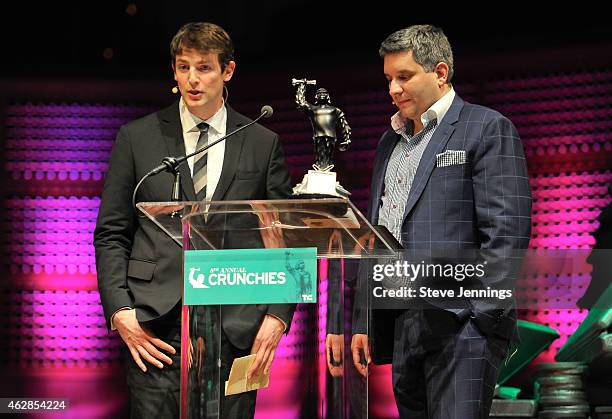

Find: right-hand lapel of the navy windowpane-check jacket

[403,95,463,220]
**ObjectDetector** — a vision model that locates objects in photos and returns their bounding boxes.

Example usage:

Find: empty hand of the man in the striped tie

[113,309,176,372]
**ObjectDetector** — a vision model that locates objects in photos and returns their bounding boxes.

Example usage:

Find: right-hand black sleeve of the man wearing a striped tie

[266,135,296,333]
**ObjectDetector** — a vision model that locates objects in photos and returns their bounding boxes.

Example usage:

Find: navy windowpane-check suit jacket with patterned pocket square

[356,96,531,362]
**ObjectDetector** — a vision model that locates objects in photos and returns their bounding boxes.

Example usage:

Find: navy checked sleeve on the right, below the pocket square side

[472,115,531,324]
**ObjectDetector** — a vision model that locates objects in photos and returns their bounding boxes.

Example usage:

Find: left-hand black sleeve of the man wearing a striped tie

[94,127,137,329]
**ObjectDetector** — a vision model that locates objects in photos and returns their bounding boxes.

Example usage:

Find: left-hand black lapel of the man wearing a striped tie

[160,101,196,201]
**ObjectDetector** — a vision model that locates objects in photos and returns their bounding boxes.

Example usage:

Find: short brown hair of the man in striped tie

[170,22,234,71]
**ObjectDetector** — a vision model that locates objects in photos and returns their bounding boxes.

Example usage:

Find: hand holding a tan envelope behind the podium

[247,315,285,380]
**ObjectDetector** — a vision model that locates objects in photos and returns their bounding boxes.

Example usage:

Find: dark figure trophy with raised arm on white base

[292,79,351,198]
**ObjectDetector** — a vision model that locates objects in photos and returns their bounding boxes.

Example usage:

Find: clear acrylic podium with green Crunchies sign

[137,199,395,419]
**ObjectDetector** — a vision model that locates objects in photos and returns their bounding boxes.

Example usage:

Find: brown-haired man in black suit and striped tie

[94,23,295,418]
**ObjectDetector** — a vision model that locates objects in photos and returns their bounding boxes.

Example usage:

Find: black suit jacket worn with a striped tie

[94,102,295,349]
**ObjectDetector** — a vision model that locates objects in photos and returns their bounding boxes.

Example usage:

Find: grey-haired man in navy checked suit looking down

[351,25,531,419]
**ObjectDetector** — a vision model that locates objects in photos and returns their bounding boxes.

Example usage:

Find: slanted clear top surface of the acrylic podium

[137,198,396,258]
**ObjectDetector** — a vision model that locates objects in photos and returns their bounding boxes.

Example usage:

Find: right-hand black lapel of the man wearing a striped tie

[212,105,246,201]
